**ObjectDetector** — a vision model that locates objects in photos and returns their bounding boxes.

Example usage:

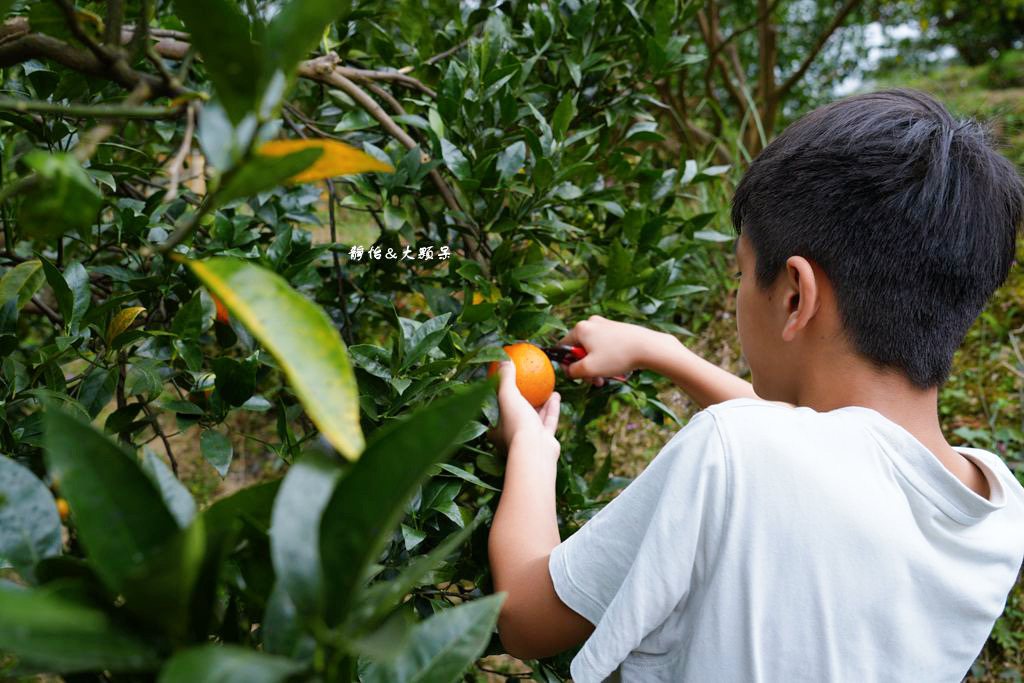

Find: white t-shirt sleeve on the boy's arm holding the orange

[548,411,728,681]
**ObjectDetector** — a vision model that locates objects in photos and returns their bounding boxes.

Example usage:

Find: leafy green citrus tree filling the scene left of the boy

[0,0,730,681]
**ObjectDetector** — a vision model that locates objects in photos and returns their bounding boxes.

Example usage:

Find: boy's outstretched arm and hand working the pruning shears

[561,315,788,409]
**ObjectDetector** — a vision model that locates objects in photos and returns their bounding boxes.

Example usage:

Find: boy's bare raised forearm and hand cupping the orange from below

[488,362,594,659]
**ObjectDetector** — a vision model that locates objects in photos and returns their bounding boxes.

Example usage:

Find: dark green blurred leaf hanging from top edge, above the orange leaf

[174,0,266,124]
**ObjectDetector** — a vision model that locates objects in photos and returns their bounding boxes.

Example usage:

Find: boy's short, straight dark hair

[732,90,1024,389]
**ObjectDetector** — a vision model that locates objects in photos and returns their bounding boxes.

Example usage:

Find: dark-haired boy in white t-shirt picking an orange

[489,90,1024,683]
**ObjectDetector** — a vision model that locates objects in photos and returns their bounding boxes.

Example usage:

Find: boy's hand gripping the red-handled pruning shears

[558,315,660,386]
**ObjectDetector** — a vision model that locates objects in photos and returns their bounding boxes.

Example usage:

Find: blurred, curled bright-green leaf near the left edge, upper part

[18,150,102,240]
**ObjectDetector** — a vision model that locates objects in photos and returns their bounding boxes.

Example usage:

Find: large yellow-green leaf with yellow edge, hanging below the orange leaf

[187,257,365,460]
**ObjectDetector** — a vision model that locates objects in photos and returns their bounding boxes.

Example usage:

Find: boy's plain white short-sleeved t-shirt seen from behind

[549,398,1024,683]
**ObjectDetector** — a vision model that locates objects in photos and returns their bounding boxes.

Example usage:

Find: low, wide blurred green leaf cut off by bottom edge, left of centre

[157,645,305,683]
